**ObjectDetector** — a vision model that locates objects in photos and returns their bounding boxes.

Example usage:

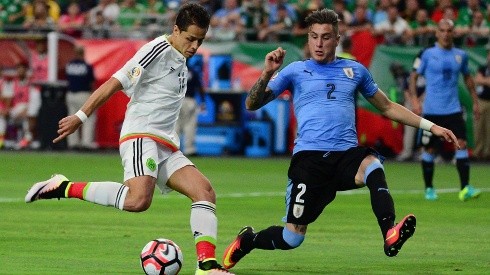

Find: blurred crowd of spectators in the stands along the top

[0,0,490,46]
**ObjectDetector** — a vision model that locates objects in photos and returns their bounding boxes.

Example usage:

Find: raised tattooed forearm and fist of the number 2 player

[245,47,286,110]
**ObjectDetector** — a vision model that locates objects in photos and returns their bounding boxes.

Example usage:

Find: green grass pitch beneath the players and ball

[0,152,490,275]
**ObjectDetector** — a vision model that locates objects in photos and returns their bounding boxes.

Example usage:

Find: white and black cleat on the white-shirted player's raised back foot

[25,174,69,203]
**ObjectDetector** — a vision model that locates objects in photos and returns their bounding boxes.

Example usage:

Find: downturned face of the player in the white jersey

[170,25,207,58]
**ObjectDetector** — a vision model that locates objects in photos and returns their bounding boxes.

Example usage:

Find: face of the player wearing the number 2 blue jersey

[308,24,339,62]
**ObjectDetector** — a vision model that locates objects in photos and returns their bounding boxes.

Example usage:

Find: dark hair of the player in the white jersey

[175,3,211,31]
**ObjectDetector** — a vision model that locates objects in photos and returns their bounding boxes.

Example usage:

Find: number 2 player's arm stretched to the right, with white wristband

[367,89,460,148]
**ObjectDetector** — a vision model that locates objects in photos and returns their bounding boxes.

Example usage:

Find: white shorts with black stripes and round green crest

[119,138,194,194]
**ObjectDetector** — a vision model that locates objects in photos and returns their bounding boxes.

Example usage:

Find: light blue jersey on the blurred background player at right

[414,44,470,115]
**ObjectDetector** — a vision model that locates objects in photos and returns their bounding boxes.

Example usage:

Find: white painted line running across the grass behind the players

[0,188,490,203]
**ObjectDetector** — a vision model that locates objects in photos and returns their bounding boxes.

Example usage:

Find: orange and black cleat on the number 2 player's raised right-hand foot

[384,214,416,257]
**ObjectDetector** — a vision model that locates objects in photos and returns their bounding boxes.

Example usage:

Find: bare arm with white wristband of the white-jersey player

[53,77,123,143]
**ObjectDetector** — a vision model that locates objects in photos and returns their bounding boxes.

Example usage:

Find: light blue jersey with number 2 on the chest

[268,59,378,154]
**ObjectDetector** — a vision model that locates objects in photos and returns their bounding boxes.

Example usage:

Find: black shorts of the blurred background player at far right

[419,113,467,148]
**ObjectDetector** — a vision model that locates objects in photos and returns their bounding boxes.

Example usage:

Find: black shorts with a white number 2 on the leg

[286,147,383,225]
